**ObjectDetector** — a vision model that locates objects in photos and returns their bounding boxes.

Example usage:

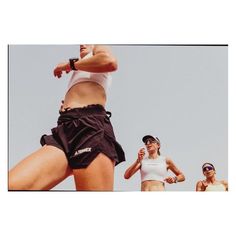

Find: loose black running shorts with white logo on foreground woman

[40,105,125,169]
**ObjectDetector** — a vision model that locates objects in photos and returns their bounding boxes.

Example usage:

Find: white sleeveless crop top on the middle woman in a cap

[140,156,167,182]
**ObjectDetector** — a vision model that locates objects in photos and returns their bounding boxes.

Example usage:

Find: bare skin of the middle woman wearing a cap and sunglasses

[124,141,185,191]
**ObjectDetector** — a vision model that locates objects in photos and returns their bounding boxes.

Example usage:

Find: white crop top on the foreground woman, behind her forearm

[67,52,112,93]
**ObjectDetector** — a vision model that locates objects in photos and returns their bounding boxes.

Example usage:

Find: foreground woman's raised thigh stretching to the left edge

[8,145,72,190]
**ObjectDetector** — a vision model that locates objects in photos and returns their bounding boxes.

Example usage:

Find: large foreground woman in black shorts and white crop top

[9,45,125,191]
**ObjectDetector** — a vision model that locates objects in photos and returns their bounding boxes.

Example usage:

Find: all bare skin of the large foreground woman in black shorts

[8,45,117,191]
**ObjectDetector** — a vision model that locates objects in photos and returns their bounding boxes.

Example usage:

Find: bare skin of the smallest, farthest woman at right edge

[196,165,228,192]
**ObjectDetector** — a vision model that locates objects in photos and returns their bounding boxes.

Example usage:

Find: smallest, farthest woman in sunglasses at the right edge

[196,163,228,191]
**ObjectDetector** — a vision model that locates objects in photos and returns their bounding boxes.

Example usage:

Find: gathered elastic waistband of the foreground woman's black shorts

[58,104,111,123]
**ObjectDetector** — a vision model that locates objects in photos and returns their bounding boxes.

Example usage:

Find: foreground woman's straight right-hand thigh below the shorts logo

[73,153,114,191]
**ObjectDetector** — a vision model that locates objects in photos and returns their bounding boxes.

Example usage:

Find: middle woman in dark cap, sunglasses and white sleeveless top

[124,135,185,191]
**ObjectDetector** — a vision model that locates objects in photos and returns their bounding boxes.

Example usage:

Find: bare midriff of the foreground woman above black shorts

[62,82,106,110]
